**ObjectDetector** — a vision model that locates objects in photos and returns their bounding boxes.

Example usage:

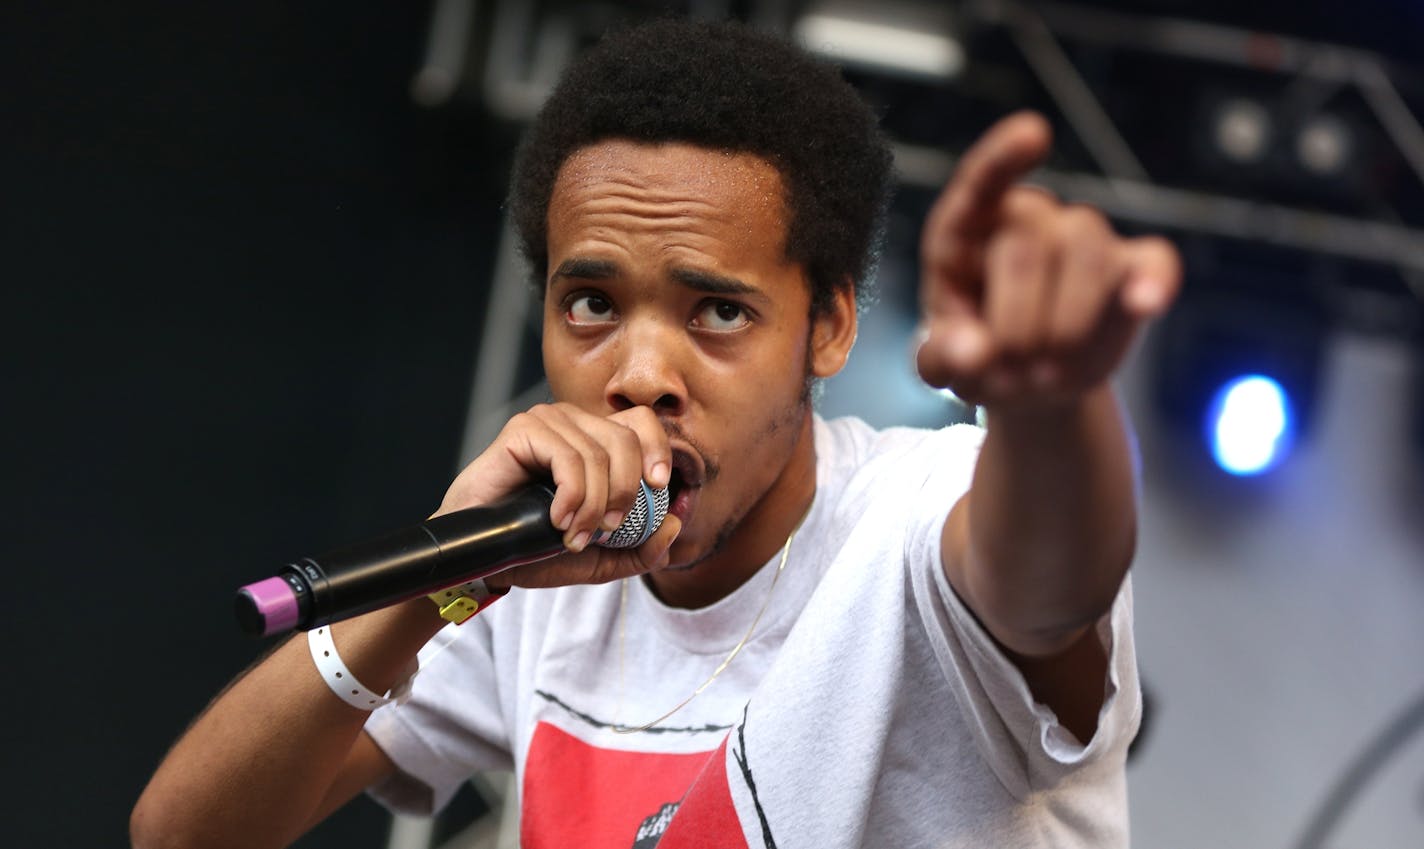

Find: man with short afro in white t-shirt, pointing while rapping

[132,23,1179,849]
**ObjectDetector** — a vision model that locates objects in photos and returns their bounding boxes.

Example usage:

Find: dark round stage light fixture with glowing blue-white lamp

[1153,280,1327,477]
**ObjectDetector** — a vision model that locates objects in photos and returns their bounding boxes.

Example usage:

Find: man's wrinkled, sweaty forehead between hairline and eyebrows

[548,138,787,248]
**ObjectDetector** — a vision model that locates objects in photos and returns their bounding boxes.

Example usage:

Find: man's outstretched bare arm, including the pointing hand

[918,114,1180,739]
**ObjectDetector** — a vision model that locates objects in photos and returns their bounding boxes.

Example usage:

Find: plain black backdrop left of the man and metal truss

[0,0,510,849]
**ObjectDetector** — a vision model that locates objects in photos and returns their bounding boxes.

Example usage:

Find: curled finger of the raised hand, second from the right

[1047,207,1126,352]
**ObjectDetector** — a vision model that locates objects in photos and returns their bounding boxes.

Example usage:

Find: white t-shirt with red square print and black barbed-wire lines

[366,419,1141,849]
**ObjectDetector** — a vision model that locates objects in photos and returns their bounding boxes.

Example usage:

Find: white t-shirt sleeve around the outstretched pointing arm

[906,433,1142,798]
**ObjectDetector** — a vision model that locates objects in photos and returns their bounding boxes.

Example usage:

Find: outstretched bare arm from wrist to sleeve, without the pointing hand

[941,387,1136,741]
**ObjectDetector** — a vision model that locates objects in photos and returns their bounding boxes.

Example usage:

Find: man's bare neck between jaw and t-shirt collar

[645,406,816,610]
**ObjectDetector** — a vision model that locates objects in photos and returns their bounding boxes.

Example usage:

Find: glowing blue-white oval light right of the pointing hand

[1206,375,1294,476]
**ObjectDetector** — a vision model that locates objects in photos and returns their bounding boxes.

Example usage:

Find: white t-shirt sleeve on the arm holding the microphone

[366,610,513,815]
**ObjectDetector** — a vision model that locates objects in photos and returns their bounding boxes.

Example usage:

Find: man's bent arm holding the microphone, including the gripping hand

[130,405,681,849]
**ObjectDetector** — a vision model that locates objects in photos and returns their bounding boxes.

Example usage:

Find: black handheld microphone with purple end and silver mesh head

[235,481,668,637]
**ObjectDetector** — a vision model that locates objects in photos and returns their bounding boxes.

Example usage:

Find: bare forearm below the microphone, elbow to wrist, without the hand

[130,598,444,849]
